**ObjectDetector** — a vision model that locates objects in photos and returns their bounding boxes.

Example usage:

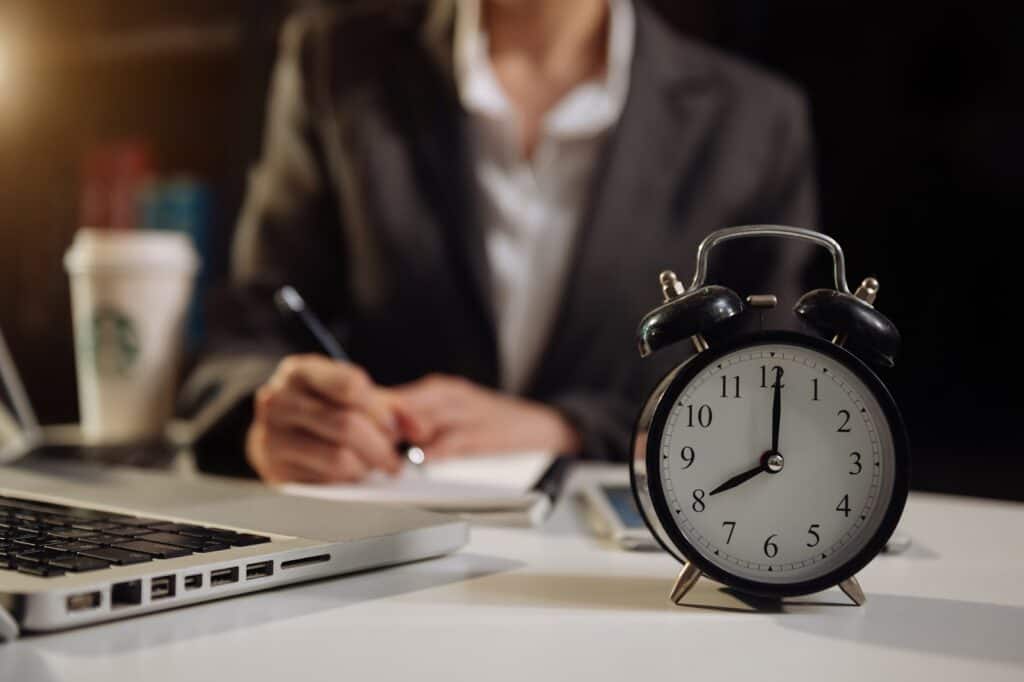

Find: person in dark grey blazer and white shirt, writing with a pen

[200,0,816,481]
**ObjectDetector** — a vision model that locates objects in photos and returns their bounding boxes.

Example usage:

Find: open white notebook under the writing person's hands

[281,452,557,526]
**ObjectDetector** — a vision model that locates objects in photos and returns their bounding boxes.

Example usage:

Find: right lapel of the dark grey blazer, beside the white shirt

[530,3,719,395]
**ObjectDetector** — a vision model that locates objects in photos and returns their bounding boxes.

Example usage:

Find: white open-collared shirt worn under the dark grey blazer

[455,0,635,393]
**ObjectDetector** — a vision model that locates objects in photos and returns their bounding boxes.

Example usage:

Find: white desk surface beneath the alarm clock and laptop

[0,462,1024,682]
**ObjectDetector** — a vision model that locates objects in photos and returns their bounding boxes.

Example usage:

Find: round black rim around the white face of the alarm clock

[630,330,910,598]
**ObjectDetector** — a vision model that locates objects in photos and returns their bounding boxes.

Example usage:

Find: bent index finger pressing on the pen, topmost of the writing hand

[279,355,397,433]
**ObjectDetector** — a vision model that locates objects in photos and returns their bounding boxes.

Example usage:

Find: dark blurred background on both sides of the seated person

[0,0,1024,499]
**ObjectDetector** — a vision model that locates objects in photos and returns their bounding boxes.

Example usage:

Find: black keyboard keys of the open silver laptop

[0,496,270,578]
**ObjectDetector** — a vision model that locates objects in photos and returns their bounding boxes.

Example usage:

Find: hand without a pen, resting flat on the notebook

[391,375,581,458]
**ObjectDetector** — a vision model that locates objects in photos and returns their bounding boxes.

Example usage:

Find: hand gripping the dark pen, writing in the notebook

[246,355,407,482]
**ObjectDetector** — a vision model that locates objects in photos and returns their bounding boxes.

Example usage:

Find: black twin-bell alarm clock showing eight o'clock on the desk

[631,225,909,605]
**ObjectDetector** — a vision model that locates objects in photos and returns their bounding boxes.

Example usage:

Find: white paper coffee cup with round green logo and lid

[65,228,199,444]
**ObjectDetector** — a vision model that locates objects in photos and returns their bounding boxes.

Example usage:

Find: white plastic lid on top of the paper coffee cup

[63,227,199,274]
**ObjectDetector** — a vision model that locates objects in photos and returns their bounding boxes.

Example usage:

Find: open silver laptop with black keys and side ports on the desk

[0,327,469,640]
